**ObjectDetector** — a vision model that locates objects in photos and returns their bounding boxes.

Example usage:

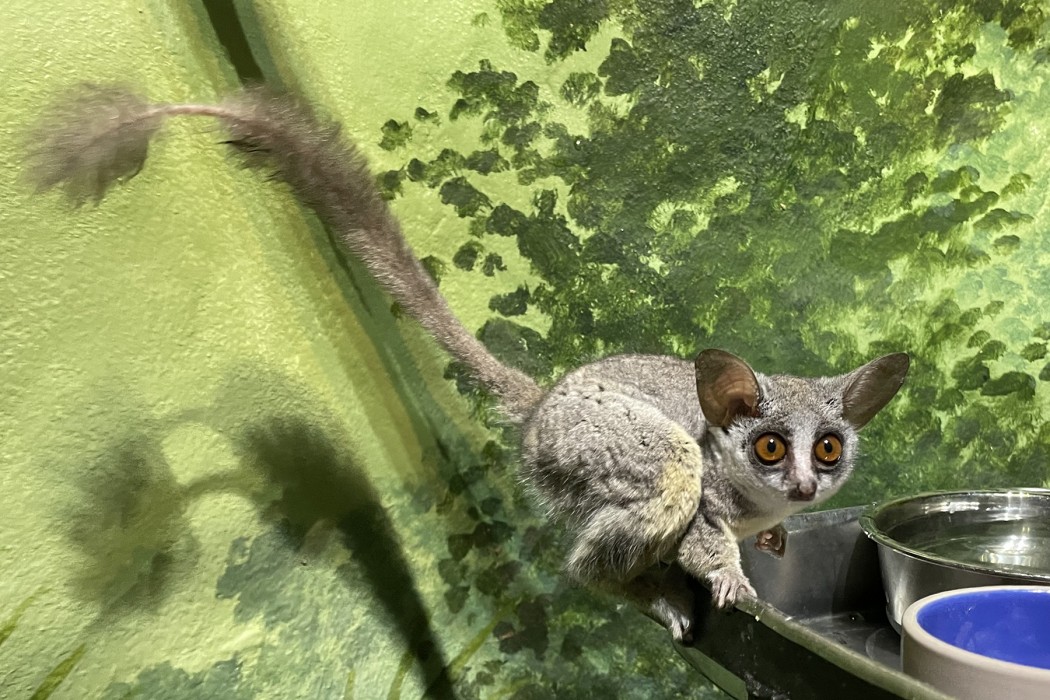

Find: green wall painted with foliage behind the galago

[0,0,1050,698]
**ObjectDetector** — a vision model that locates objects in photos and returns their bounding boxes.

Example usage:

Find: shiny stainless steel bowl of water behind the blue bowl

[860,489,1050,632]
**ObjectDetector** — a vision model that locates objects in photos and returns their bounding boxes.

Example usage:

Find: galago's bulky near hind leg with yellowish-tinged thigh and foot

[523,383,701,640]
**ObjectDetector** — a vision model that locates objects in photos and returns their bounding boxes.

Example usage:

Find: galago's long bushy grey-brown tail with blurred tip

[27,85,542,420]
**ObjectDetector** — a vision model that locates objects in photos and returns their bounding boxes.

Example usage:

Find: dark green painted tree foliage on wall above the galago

[383,0,1050,503]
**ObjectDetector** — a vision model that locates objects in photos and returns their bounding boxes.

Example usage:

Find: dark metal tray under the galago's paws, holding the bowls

[677,507,948,700]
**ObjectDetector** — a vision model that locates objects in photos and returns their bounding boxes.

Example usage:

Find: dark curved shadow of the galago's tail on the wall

[61,372,454,698]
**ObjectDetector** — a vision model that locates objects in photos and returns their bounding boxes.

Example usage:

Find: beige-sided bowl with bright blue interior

[901,586,1050,700]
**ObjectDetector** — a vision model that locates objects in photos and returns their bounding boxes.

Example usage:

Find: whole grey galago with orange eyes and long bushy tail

[28,86,908,640]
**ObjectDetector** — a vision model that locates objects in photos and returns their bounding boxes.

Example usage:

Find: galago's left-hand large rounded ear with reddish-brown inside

[695,349,761,428]
